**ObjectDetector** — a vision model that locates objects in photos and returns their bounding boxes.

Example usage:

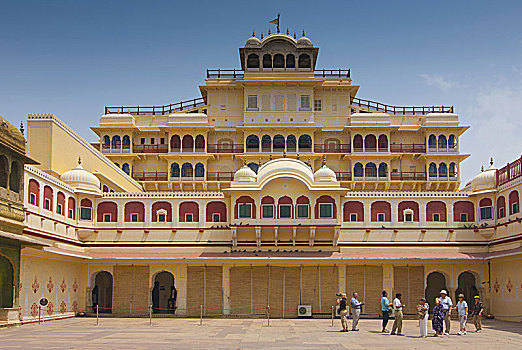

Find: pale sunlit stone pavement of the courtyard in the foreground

[0,318,522,350]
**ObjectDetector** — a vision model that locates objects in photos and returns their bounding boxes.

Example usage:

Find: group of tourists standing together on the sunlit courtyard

[337,289,484,338]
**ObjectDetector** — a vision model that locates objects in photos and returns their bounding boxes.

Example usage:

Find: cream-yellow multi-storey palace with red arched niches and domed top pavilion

[0,33,522,322]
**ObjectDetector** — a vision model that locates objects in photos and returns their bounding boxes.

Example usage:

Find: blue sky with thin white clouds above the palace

[0,0,522,183]
